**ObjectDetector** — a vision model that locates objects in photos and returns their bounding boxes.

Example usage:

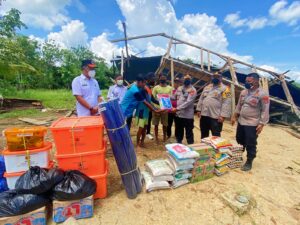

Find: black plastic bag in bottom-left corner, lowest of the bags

[0,190,50,217]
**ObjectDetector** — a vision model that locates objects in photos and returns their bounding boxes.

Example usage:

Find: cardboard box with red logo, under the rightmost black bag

[53,196,94,223]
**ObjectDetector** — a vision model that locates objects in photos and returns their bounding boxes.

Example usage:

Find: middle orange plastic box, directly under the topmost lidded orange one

[56,138,107,176]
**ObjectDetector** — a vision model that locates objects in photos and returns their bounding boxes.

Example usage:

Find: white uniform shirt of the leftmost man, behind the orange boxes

[72,74,101,116]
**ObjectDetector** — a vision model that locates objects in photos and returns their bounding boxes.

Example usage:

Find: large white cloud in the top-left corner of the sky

[0,0,72,30]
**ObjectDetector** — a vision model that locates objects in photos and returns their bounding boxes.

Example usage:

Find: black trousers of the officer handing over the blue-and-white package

[175,117,194,144]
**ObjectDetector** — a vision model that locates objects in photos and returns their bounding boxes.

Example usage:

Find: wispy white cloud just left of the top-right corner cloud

[224,12,268,30]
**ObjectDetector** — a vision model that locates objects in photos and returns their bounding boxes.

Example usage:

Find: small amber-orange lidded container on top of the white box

[3,127,47,151]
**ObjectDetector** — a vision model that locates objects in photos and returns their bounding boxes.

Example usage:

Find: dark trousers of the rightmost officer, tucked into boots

[236,124,258,160]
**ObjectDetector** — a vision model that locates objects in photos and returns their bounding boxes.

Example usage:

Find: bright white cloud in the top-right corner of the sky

[269,0,300,26]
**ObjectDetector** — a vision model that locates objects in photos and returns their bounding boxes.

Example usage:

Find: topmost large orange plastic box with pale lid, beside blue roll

[50,116,104,155]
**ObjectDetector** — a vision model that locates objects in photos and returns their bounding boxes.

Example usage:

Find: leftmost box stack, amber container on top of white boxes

[2,127,52,189]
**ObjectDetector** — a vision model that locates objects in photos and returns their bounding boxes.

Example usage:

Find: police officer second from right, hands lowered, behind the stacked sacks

[197,73,231,139]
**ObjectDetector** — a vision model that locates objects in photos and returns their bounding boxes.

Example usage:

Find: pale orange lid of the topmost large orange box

[50,116,104,130]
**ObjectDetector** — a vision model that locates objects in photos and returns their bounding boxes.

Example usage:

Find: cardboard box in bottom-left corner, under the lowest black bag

[0,207,47,225]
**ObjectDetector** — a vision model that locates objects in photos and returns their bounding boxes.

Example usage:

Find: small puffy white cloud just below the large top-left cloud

[47,20,88,48]
